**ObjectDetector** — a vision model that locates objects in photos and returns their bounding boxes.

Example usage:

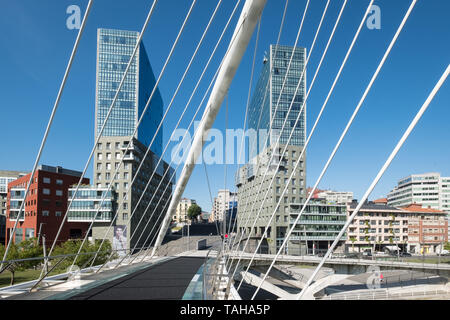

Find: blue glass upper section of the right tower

[248,45,306,159]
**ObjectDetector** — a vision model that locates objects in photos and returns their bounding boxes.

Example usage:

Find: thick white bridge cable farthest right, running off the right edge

[297,65,450,300]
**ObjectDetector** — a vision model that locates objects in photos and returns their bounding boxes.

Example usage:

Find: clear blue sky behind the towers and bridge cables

[0,0,450,211]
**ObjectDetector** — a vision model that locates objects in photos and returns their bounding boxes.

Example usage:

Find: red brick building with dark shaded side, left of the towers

[5,166,89,245]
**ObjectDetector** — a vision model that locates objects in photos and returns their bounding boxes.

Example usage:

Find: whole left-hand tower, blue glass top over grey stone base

[92,29,174,249]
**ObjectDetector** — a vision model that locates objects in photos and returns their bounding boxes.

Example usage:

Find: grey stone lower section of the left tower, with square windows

[92,137,175,249]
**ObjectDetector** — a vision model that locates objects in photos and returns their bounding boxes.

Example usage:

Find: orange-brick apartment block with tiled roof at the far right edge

[401,204,448,254]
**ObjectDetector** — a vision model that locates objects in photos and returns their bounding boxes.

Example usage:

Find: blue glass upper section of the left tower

[95,29,163,155]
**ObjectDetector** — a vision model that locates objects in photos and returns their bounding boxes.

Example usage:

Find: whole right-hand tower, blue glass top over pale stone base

[236,45,306,252]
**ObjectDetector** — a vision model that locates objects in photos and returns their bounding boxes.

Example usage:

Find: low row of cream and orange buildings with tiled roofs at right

[346,202,448,254]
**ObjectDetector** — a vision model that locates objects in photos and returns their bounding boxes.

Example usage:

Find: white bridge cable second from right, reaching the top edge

[252,0,417,299]
